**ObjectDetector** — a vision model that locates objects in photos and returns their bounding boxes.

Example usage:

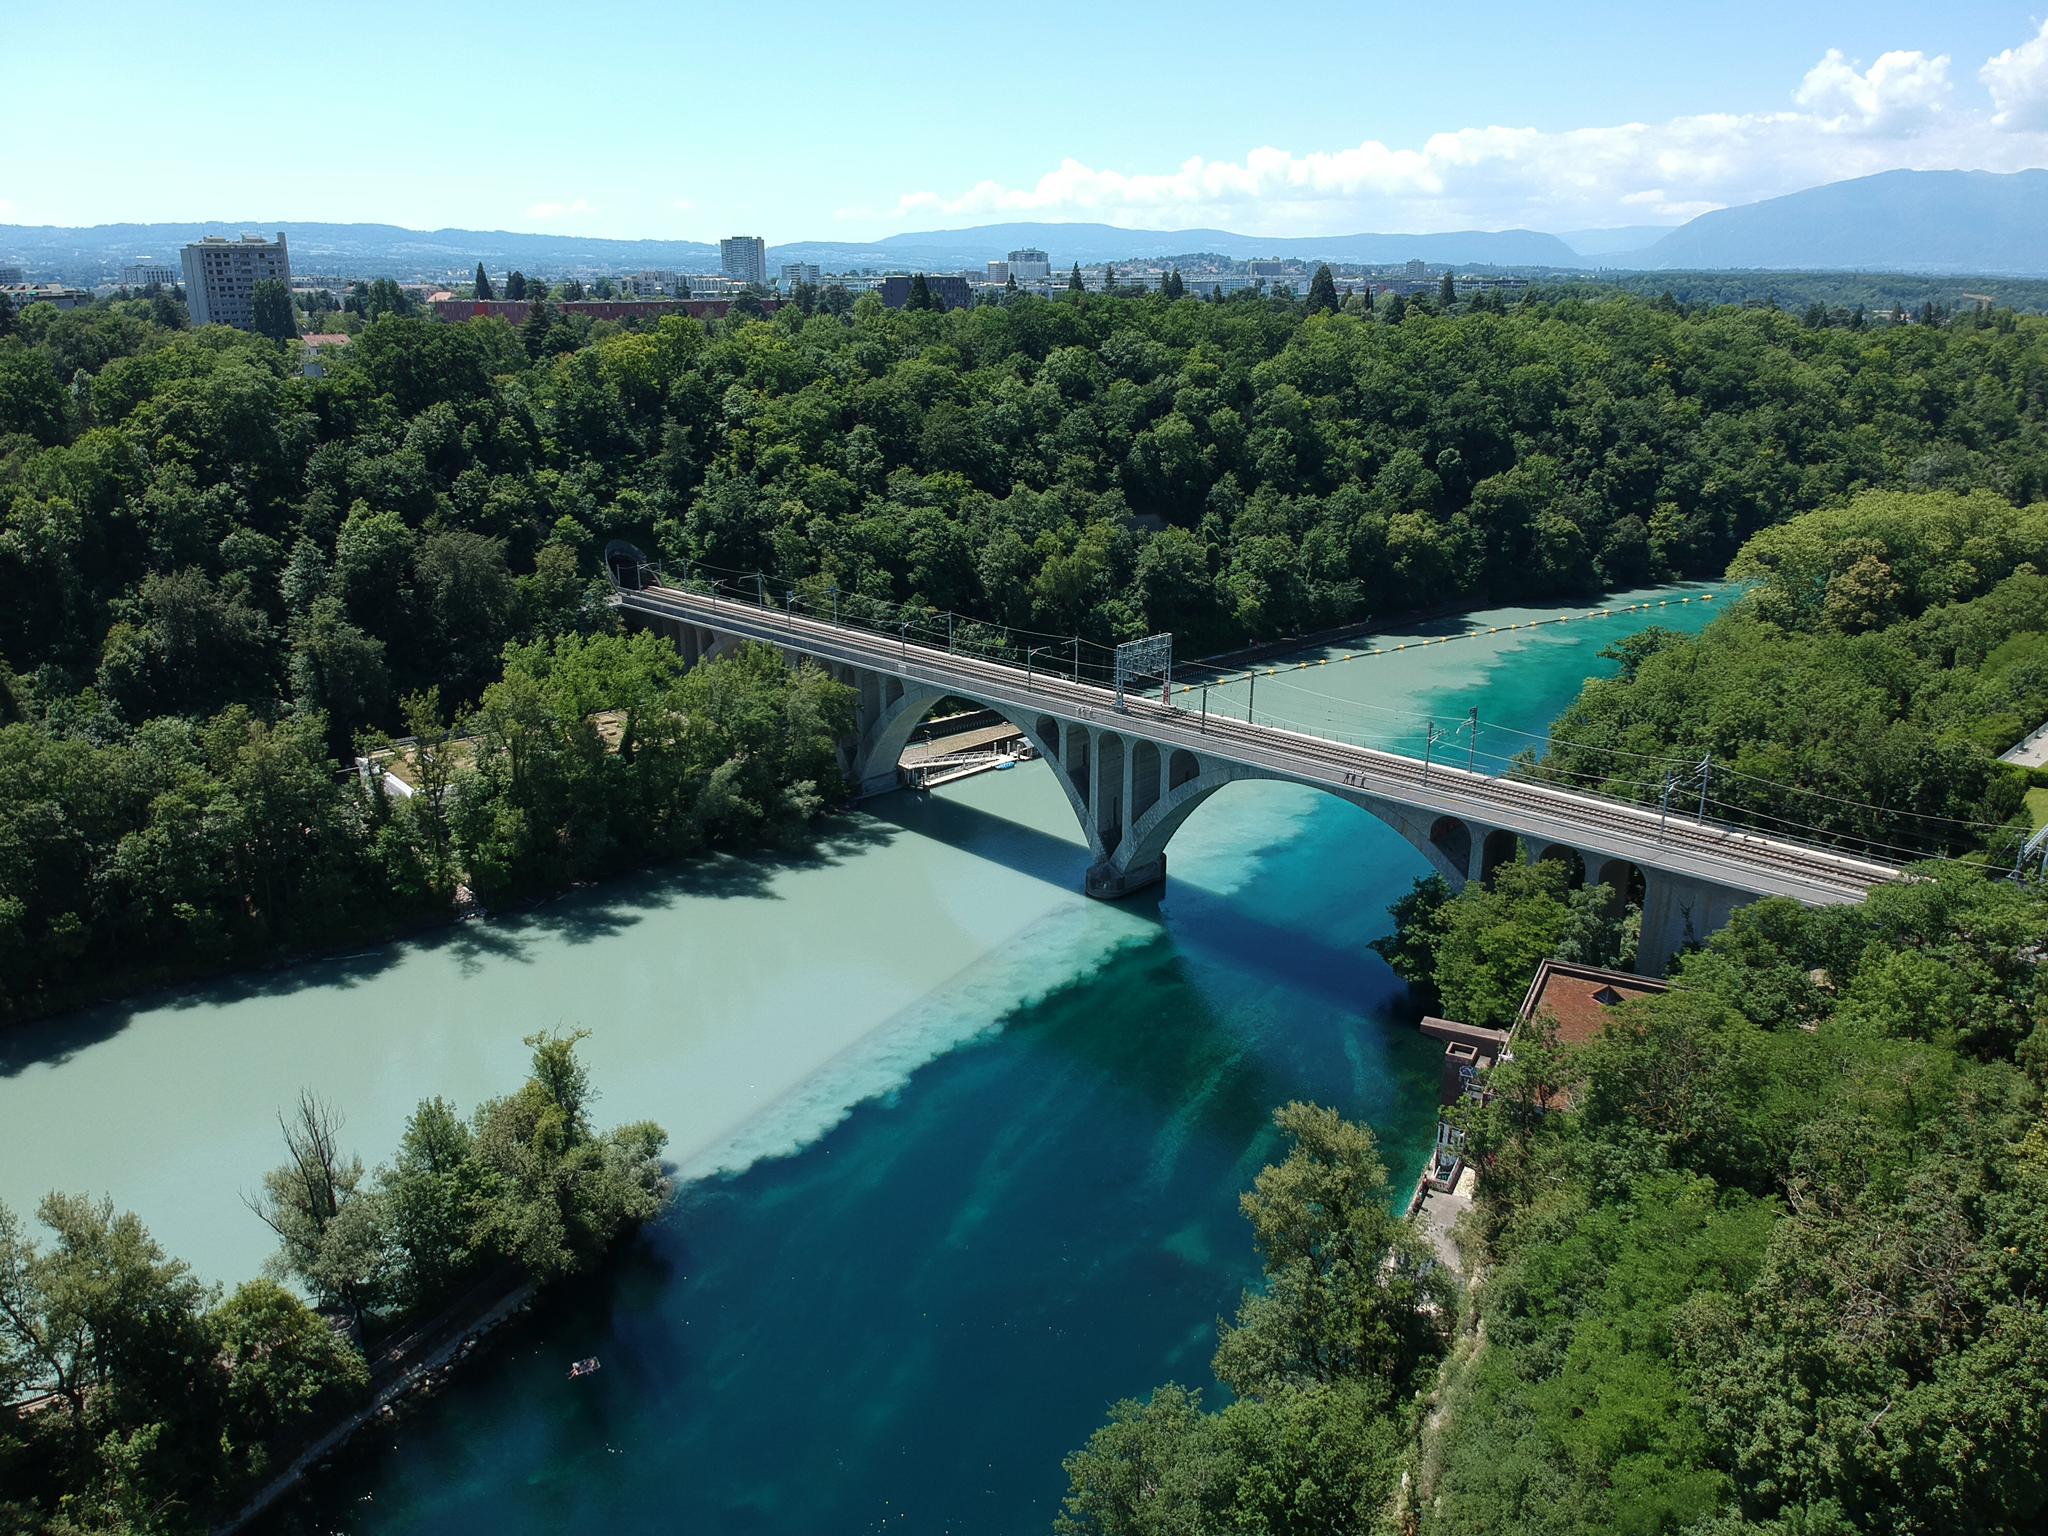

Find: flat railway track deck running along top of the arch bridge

[621,586,1901,903]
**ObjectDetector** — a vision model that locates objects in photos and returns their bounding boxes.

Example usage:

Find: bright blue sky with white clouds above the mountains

[0,0,2048,242]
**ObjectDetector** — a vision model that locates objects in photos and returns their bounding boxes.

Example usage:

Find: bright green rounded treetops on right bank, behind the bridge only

[1534,492,2048,858]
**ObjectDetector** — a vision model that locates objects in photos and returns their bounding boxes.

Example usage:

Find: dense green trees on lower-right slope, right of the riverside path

[1417,866,2048,1536]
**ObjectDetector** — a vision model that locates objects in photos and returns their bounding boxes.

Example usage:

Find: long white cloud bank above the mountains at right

[888,29,2048,233]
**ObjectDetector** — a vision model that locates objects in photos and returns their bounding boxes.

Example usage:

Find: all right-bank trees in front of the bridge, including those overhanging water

[1059,864,2048,1536]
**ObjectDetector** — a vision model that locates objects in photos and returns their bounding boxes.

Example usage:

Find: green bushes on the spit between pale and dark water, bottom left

[0,1030,672,1536]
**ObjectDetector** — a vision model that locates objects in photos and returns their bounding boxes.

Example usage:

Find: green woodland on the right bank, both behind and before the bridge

[1061,494,2048,1536]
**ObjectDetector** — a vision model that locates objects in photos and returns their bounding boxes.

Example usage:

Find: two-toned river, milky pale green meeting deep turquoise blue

[0,588,1714,1536]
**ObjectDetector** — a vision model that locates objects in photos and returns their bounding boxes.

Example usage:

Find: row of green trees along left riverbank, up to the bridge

[0,633,852,1024]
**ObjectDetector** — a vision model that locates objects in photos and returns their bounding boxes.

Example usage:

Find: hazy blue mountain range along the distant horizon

[12,170,2048,281]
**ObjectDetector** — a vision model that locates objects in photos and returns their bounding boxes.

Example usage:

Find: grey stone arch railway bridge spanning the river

[618,586,1898,971]
